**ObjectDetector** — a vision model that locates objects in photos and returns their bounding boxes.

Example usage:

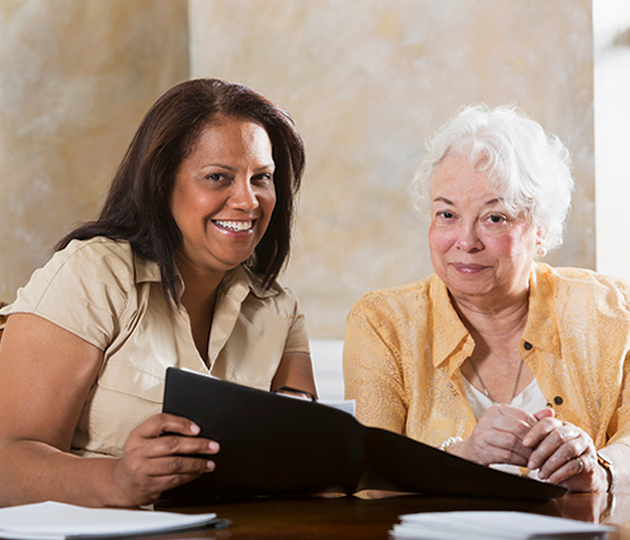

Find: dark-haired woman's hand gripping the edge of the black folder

[113,413,219,506]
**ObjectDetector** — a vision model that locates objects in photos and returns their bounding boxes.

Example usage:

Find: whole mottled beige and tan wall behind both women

[0,0,595,338]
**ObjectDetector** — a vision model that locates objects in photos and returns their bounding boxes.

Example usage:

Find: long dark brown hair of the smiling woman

[55,79,305,304]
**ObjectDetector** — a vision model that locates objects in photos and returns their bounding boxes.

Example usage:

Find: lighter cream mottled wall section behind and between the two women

[189,0,595,338]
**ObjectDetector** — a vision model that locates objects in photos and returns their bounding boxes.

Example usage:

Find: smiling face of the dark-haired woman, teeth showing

[170,118,276,275]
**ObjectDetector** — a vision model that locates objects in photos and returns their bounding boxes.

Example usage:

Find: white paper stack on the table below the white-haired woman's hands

[390,511,615,540]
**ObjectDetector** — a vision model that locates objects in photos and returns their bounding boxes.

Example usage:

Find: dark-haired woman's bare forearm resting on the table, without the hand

[0,441,131,507]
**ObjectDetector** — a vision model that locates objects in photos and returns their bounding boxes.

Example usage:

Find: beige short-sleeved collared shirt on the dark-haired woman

[0,237,309,456]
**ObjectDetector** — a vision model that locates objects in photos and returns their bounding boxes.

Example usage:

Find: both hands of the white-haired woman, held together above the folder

[452,404,608,492]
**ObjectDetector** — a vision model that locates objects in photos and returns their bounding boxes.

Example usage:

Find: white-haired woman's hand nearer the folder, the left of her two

[452,404,538,467]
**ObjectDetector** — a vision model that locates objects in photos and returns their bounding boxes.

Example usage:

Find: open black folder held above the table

[158,368,566,504]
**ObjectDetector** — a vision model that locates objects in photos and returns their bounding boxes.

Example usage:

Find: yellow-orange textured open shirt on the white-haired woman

[343,263,630,448]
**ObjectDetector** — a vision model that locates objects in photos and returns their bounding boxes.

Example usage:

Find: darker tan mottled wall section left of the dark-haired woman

[0,0,188,300]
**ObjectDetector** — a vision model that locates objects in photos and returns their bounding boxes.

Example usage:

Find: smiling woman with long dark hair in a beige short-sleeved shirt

[0,79,315,506]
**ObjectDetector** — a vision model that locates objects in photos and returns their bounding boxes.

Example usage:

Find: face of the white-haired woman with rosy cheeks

[429,155,538,307]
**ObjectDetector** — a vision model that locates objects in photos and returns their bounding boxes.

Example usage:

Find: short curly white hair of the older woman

[411,104,574,256]
